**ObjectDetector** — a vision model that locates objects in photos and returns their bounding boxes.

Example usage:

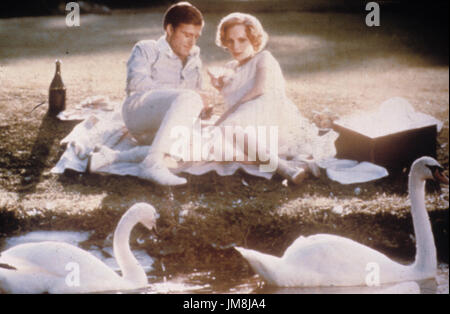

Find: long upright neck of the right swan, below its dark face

[408,174,437,272]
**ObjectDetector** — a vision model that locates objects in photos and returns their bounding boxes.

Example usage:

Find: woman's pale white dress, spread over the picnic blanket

[218,50,337,160]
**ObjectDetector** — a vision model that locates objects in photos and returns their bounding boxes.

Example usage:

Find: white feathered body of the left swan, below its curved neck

[0,242,123,292]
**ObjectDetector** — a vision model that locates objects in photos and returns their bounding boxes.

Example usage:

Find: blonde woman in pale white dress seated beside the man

[208,13,336,183]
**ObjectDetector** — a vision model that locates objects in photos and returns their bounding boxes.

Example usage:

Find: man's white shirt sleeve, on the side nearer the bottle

[126,42,158,95]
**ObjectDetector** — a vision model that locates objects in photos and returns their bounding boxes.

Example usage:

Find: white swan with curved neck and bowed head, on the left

[0,203,157,293]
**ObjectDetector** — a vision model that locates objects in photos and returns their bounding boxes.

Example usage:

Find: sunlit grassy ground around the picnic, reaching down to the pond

[0,6,449,280]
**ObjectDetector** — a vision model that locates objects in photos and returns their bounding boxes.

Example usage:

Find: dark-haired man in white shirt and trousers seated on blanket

[122,2,204,185]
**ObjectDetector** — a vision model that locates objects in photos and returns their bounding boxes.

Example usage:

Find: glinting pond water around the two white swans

[0,231,449,294]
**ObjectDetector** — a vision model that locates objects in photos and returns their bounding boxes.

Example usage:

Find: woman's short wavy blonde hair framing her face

[216,12,269,53]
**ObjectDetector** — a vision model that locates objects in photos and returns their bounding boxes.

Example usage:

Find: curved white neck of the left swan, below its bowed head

[114,215,147,284]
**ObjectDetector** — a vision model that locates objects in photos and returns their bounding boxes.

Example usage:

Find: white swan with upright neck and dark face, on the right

[235,157,448,287]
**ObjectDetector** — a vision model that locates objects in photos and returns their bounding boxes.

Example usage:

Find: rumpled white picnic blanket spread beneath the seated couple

[51,96,398,184]
